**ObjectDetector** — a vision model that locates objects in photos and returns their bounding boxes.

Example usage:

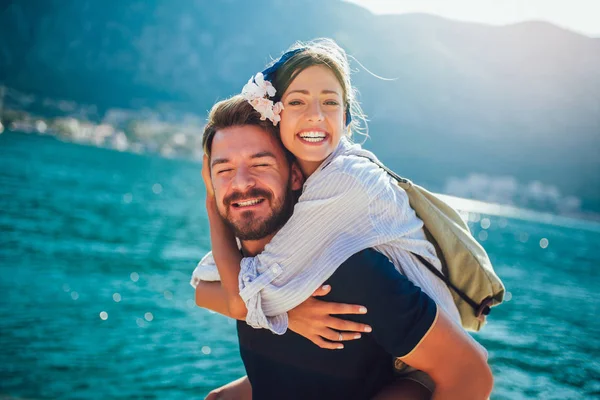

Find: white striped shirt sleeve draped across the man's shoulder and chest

[239,164,380,334]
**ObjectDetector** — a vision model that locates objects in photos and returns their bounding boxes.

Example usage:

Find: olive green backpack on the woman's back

[369,158,504,331]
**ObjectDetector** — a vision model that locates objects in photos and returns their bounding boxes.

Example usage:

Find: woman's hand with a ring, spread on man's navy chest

[288,285,371,350]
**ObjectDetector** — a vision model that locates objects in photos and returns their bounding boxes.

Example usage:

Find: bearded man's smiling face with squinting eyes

[210,125,302,240]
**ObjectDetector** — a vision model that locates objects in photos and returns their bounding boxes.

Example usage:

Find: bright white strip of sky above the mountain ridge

[346,0,600,36]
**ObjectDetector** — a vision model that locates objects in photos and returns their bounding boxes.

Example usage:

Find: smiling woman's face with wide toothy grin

[280,65,345,174]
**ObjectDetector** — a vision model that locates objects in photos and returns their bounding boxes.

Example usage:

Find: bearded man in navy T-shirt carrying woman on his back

[196,96,492,399]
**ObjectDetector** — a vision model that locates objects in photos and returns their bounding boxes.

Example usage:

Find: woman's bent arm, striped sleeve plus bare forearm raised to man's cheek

[203,155,387,334]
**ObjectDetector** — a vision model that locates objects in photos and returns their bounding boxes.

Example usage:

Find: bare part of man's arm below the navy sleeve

[400,309,493,399]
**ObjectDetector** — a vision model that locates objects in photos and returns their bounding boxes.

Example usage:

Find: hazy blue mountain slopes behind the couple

[0,0,600,211]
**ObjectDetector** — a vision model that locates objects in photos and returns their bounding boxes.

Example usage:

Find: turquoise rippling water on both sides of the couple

[0,132,600,399]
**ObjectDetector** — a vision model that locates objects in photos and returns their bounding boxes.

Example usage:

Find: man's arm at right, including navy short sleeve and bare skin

[328,249,493,399]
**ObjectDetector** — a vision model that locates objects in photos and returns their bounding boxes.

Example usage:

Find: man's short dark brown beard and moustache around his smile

[219,179,297,240]
